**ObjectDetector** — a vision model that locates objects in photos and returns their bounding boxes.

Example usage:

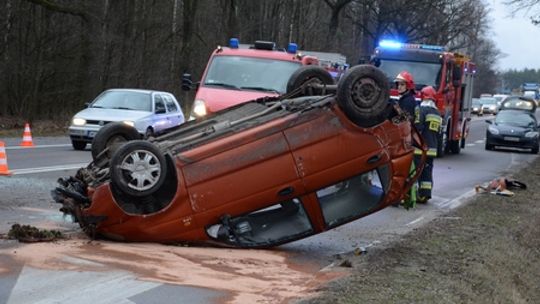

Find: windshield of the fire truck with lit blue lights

[379,59,442,89]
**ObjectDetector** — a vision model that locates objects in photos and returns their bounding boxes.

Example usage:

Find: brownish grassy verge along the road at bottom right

[300,158,540,304]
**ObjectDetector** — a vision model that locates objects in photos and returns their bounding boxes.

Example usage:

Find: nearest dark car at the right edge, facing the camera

[485,96,540,154]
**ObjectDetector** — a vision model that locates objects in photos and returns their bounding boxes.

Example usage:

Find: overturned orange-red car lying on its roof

[53,65,426,247]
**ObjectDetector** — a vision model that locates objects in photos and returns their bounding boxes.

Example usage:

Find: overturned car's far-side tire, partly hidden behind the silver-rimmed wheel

[92,122,141,161]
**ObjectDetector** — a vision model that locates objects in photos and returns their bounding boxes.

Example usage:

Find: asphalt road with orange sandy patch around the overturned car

[0,117,537,304]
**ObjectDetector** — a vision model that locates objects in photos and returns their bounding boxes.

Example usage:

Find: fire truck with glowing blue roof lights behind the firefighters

[370,40,476,157]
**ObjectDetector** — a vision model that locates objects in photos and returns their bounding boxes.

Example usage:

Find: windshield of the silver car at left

[90,91,152,112]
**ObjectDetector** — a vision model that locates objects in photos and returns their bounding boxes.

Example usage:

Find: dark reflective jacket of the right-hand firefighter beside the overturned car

[414,99,442,157]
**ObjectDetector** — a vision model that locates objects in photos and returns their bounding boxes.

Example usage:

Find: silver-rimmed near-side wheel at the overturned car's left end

[110,140,167,197]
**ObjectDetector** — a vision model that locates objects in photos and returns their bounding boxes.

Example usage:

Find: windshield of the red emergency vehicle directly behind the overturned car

[203,56,300,93]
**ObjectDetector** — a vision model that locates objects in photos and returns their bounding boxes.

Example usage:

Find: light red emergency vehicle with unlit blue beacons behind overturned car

[182,38,348,120]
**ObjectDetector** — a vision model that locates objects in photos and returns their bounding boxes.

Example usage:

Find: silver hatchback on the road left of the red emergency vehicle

[69,89,184,150]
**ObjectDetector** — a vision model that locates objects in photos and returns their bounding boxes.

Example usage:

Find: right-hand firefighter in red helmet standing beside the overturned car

[414,86,442,203]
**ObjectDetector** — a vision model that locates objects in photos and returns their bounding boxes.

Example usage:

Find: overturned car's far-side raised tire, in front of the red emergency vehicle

[287,65,334,97]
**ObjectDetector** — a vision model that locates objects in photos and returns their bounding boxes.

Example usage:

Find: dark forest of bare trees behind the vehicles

[0,0,540,123]
